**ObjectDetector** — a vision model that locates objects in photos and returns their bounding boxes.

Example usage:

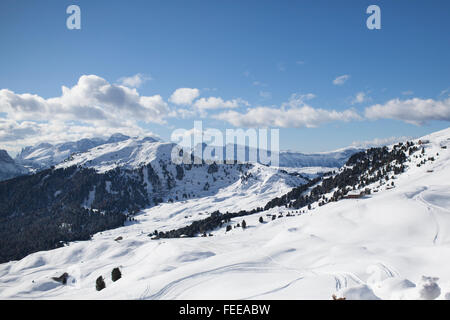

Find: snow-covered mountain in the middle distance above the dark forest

[56,138,307,209]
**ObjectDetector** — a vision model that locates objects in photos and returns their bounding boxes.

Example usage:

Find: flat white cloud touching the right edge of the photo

[365,98,450,125]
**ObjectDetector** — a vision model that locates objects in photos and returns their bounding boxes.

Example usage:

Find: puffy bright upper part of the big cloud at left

[0,75,169,126]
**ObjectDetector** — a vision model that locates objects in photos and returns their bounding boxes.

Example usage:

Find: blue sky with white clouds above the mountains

[0,0,450,152]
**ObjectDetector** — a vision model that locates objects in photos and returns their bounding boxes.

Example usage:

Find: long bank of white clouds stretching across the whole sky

[0,74,450,151]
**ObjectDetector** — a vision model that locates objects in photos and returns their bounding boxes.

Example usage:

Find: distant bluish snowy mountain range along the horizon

[0,133,363,181]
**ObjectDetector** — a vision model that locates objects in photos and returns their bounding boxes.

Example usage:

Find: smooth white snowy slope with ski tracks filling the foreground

[0,129,450,299]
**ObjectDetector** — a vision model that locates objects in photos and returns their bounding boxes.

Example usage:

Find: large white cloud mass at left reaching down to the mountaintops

[0,75,171,151]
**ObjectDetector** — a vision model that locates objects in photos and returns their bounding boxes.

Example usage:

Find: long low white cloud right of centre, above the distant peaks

[213,94,361,128]
